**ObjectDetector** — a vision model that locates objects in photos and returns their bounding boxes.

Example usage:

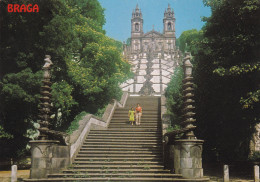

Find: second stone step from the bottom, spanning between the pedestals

[48,171,181,180]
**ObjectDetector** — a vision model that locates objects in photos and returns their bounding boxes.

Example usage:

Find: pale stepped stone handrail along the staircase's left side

[69,92,129,161]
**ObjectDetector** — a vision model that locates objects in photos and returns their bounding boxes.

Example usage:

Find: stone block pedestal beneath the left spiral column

[30,140,70,179]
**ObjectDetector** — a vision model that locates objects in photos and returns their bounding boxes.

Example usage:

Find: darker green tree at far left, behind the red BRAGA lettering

[0,0,74,157]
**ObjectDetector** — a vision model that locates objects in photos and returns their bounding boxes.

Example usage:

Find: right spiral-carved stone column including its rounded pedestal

[173,53,204,178]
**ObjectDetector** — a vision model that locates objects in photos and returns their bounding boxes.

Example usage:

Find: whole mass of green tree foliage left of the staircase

[0,0,130,156]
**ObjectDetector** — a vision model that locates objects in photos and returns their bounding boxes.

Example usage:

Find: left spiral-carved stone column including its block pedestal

[30,55,70,179]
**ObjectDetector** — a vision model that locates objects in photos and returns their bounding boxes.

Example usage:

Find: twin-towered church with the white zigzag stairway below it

[121,5,181,96]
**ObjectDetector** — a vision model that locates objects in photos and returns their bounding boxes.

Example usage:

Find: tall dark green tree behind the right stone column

[194,0,260,160]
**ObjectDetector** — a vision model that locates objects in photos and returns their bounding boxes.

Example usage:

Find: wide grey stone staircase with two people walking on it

[26,97,207,182]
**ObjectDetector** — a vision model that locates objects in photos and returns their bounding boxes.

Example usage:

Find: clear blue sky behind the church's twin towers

[99,0,211,41]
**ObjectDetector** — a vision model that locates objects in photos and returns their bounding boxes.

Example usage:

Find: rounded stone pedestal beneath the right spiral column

[173,139,204,178]
